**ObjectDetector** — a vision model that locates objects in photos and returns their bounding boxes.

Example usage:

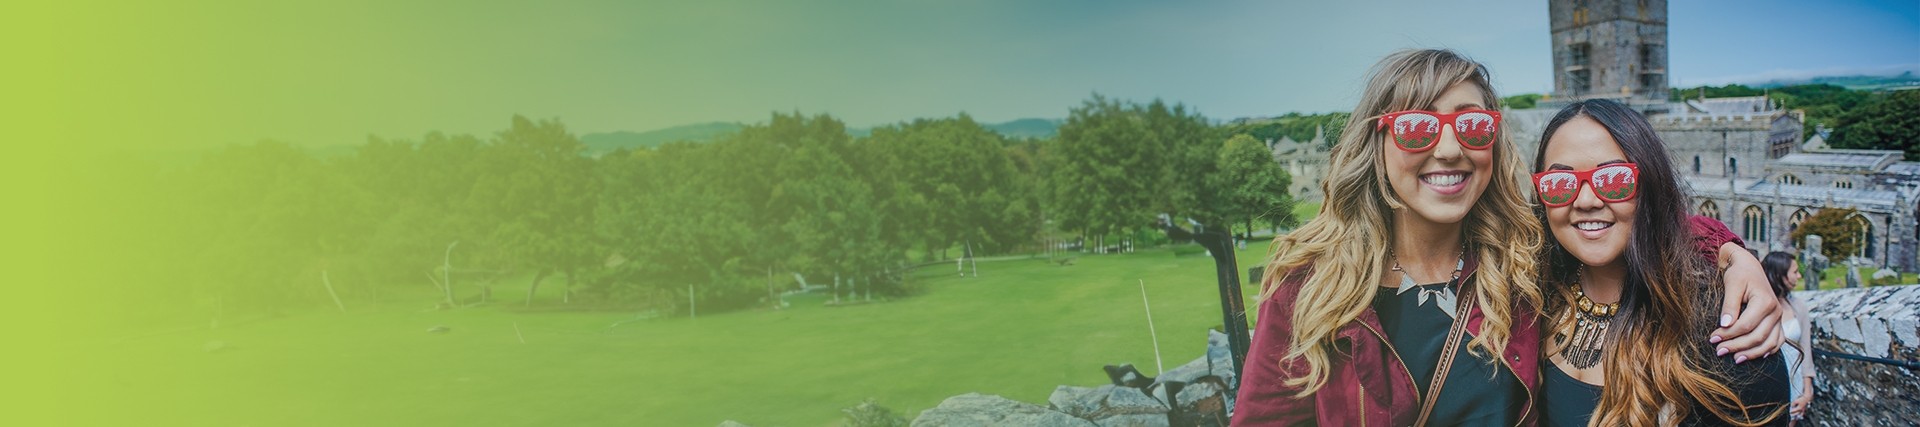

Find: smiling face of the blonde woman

[1380,81,1500,223]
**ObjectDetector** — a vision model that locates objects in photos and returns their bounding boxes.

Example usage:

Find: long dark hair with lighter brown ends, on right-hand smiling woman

[1534,100,1778,425]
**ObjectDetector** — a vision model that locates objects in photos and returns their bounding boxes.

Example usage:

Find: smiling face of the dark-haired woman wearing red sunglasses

[1542,115,1640,267]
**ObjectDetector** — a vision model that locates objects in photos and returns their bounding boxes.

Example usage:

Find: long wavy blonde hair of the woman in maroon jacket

[1261,50,1542,396]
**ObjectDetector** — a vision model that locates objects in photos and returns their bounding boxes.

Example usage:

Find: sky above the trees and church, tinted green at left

[0,0,1920,148]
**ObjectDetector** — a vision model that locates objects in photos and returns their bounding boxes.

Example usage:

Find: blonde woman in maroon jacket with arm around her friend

[1233,50,1778,425]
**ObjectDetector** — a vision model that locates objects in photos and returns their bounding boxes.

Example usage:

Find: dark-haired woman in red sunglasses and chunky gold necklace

[1534,100,1788,425]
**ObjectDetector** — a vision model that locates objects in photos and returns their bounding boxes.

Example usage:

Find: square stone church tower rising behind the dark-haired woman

[1548,0,1667,113]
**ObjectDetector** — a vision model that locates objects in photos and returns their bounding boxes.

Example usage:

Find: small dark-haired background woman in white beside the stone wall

[1761,252,1814,423]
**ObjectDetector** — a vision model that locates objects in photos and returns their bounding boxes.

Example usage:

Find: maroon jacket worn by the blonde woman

[1233,258,1542,425]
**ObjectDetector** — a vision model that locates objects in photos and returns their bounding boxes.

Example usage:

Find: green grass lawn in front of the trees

[63,242,1265,425]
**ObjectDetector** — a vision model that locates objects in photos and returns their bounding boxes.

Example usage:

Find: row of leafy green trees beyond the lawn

[102,96,1294,319]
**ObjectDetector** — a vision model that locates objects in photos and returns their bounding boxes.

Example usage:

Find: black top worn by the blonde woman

[1373,283,1526,427]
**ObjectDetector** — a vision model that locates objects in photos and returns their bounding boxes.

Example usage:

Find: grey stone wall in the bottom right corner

[1795,285,1920,427]
